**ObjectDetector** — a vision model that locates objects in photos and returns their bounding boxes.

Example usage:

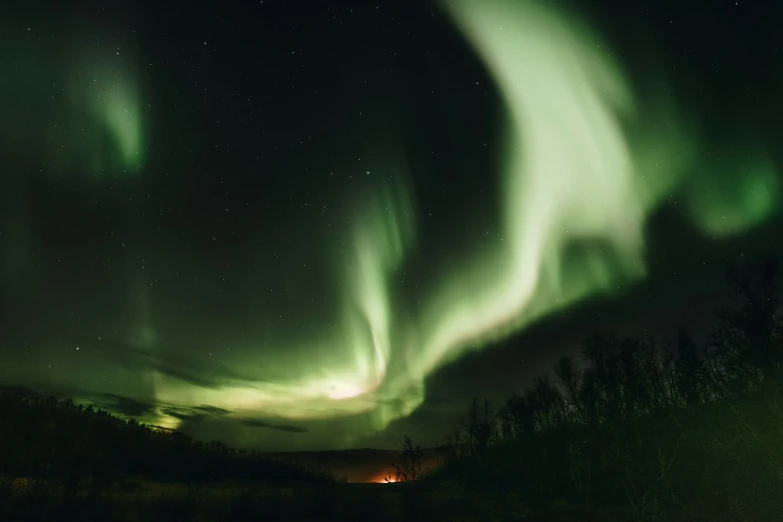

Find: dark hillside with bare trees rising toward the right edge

[396,261,783,520]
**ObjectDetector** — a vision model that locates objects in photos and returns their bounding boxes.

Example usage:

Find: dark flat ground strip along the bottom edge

[0,480,612,522]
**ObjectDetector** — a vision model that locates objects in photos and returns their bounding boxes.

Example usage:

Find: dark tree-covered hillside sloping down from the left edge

[0,388,334,486]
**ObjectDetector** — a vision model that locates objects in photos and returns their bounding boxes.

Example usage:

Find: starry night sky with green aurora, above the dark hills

[0,0,783,451]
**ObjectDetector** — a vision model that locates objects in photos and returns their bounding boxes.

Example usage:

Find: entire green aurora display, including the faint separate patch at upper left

[0,0,781,445]
